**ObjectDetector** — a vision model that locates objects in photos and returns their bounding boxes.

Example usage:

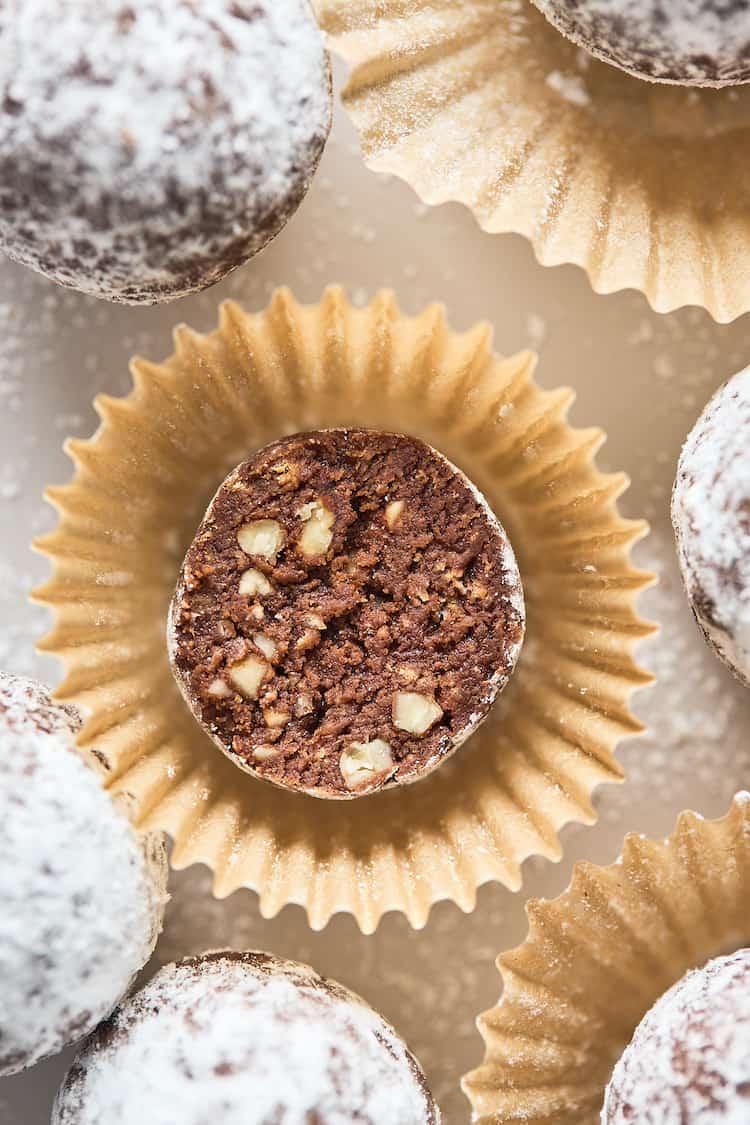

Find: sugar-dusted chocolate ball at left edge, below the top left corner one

[0,673,166,1076]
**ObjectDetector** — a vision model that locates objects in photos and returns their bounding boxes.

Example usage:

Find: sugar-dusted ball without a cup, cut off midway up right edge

[672,368,750,683]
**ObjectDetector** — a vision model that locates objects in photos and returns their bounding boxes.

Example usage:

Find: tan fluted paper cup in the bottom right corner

[462,793,750,1125]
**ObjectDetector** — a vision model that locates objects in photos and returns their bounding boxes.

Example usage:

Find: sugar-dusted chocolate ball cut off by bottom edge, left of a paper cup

[52,953,440,1125]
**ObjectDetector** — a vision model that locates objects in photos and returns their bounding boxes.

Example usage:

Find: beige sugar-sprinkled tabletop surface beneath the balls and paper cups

[0,65,750,1125]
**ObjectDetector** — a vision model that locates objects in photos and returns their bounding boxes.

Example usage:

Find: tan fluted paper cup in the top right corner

[316,0,750,322]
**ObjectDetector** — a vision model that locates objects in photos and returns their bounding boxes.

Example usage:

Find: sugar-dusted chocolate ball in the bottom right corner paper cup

[602,950,750,1125]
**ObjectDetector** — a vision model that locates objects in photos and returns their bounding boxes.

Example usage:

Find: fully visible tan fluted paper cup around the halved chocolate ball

[30,289,650,932]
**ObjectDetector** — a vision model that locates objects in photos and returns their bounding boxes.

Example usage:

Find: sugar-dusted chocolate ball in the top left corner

[0,0,332,304]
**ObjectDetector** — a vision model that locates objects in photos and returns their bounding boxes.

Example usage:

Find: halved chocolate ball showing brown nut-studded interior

[169,430,524,798]
